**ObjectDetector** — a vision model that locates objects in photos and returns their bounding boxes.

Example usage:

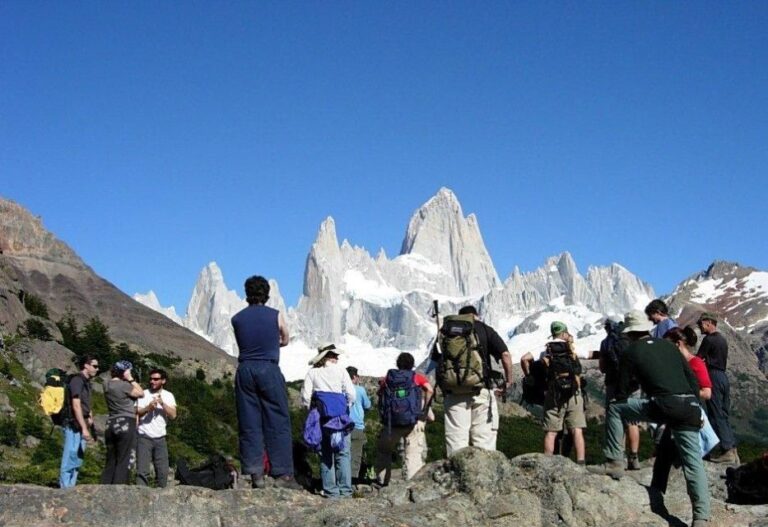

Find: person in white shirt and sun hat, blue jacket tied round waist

[301,344,356,499]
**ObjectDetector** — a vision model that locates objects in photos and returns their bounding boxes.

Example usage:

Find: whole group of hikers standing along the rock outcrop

[49,276,739,527]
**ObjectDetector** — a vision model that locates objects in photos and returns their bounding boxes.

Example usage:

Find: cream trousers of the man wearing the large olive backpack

[445,388,499,457]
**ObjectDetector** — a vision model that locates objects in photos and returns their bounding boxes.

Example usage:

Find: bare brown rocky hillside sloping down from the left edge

[0,198,233,378]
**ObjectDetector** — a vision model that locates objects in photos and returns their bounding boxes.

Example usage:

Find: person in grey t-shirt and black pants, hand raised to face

[101,360,144,485]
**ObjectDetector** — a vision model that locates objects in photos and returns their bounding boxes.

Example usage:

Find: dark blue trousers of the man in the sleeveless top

[235,361,293,477]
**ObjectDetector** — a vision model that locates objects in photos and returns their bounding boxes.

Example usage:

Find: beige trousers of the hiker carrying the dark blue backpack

[376,421,427,485]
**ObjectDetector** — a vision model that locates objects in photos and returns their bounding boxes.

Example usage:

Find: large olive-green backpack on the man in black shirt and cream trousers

[436,314,487,394]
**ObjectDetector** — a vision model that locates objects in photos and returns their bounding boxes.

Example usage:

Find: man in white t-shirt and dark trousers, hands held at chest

[136,368,176,487]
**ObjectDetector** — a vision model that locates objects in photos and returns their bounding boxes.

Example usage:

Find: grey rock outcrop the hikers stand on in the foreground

[0,449,768,527]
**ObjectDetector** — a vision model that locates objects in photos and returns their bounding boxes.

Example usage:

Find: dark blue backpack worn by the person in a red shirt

[379,370,423,427]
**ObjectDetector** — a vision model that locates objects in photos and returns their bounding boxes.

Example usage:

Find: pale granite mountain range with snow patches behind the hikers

[135,188,655,376]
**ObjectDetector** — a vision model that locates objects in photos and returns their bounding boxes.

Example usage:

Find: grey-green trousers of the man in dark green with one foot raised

[603,399,709,520]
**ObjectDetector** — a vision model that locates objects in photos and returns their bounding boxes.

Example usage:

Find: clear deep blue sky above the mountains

[0,0,768,312]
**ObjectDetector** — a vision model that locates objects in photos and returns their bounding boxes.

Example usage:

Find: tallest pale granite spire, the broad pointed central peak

[400,187,501,296]
